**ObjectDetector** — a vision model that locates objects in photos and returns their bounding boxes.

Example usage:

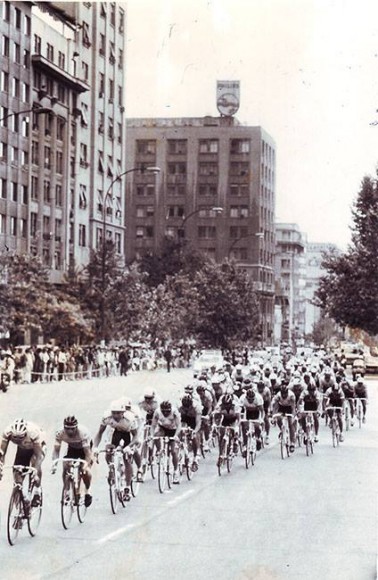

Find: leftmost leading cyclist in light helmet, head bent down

[0,419,46,507]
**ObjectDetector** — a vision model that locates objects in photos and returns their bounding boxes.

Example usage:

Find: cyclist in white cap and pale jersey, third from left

[94,399,143,501]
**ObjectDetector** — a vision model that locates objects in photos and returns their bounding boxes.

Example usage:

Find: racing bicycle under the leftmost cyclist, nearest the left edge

[6,465,42,546]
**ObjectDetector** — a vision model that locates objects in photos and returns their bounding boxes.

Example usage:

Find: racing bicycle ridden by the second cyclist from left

[53,457,87,530]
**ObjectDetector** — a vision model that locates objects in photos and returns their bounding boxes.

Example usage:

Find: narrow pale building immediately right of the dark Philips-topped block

[275,223,306,342]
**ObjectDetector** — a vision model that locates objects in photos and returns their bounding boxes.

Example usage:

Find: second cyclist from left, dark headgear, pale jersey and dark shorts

[51,415,93,507]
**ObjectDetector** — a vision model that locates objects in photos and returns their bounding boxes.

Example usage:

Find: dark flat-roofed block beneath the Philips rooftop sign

[126,117,275,342]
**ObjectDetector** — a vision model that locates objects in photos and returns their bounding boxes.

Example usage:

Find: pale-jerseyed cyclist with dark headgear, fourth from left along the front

[151,401,181,484]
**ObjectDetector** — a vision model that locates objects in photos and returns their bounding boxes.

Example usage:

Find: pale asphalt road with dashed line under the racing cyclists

[0,370,378,580]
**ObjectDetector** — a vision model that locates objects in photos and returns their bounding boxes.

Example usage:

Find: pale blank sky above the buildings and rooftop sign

[127,0,378,248]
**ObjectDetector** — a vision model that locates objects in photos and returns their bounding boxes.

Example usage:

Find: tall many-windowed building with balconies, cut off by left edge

[0,2,125,282]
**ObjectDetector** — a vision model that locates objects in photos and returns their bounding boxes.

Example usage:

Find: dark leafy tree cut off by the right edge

[316,177,378,334]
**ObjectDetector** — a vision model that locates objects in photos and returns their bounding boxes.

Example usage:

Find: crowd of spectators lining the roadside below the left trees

[0,345,193,383]
